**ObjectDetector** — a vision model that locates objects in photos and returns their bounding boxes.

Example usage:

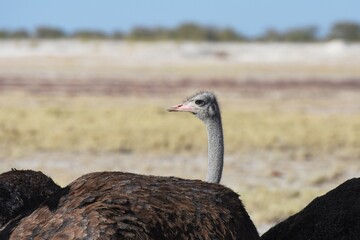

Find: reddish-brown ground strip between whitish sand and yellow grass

[0,77,360,95]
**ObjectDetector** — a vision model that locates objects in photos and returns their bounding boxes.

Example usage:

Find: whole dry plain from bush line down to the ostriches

[0,40,360,232]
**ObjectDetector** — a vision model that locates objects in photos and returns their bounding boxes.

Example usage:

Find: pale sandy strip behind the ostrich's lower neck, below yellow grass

[1,152,360,189]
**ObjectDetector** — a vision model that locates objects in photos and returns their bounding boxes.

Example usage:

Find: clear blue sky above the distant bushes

[0,0,360,36]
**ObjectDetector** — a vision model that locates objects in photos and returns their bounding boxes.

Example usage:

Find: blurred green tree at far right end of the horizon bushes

[327,22,360,42]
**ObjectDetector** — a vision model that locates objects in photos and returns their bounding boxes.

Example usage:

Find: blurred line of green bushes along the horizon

[0,21,360,42]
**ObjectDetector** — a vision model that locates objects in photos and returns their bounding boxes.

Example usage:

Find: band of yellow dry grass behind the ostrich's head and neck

[0,94,360,159]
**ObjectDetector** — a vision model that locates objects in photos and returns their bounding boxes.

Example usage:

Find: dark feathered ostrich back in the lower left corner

[0,169,61,229]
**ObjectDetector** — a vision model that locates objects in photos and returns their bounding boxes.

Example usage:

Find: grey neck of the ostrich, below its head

[205,116,224,183]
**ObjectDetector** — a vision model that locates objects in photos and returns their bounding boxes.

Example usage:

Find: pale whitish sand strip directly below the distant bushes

[0,40,360,81]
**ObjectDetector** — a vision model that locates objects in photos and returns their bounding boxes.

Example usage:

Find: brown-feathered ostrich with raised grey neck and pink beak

[0,92,259,240]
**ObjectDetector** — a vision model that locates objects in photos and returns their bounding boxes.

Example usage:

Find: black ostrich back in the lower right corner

[261,178,360,240]
